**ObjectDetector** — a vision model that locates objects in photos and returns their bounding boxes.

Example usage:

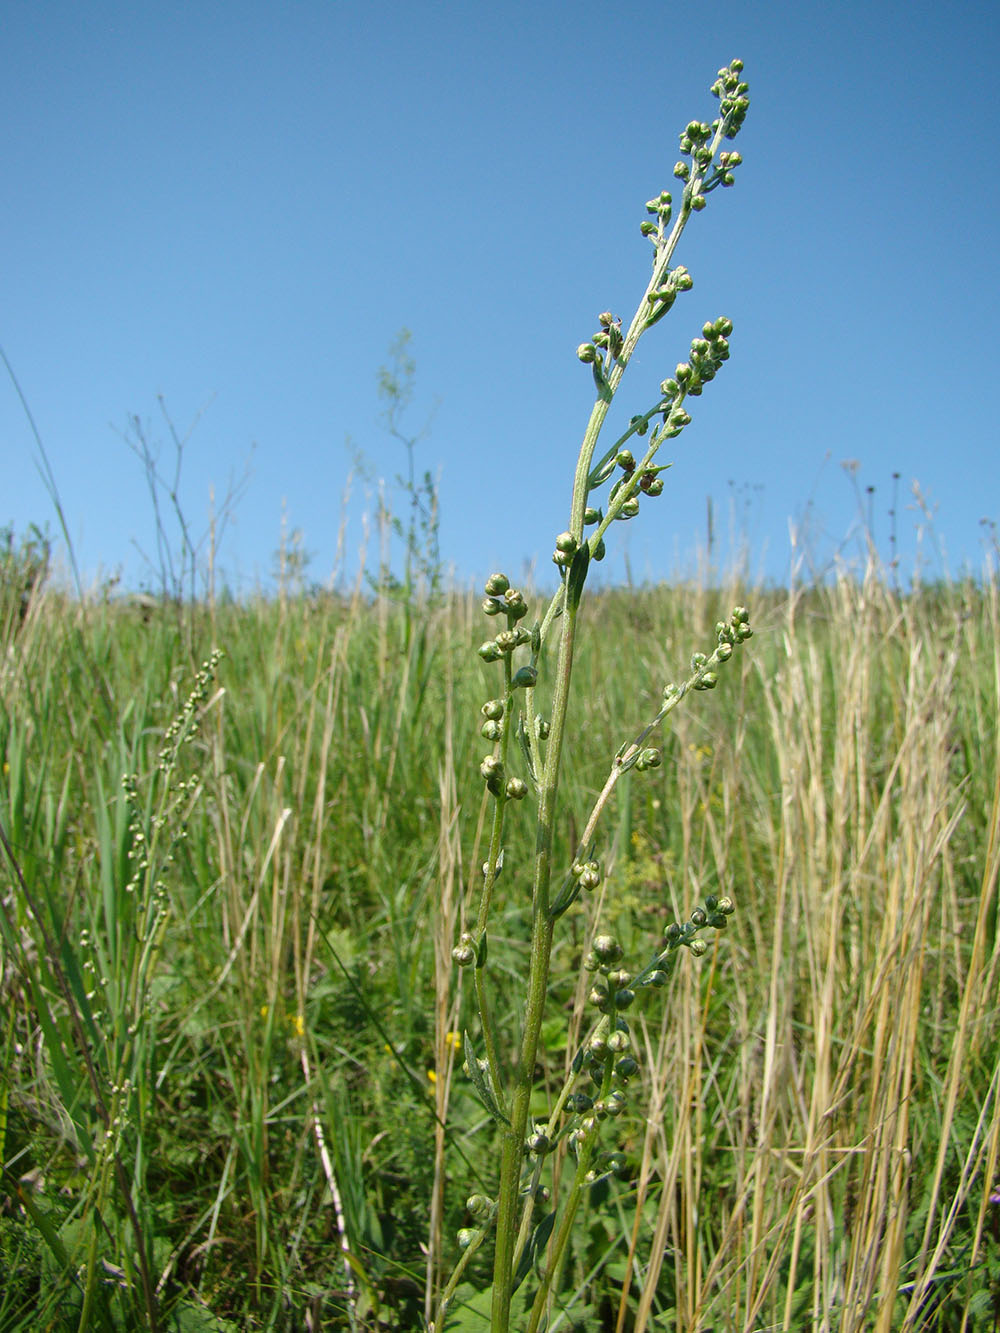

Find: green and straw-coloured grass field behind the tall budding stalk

[0,557,1000,1333]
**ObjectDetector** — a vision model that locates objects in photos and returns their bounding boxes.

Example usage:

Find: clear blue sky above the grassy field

[0,0,1000,589]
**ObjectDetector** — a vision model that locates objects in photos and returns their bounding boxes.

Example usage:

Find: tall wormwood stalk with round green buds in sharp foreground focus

[433,60,751,1333]
